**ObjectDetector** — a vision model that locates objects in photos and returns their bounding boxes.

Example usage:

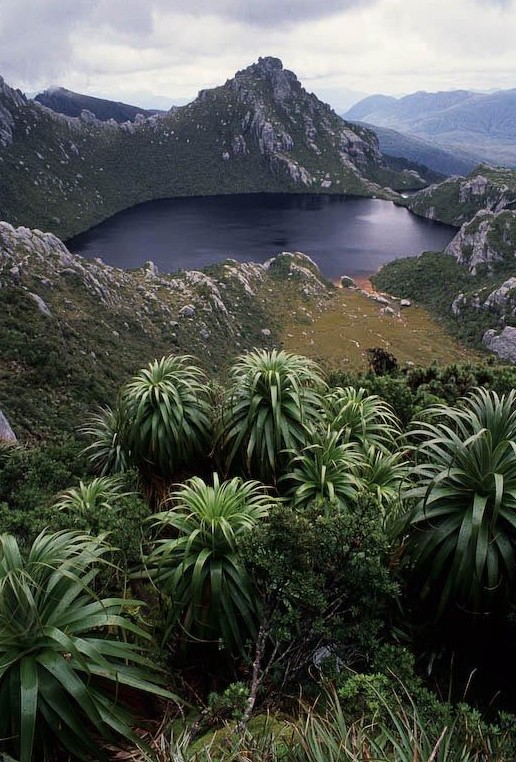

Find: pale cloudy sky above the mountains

[0,0,516,108]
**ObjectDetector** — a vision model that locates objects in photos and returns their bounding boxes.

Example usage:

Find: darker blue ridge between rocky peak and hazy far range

[352,122,478,176]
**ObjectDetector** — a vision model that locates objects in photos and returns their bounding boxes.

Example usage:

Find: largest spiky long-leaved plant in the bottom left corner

[0,532,173,762]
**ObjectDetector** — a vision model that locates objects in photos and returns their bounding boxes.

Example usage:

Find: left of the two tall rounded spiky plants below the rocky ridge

[121,355,211,478]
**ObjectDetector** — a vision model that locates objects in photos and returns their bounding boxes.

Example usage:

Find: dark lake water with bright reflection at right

[67,194,456,279]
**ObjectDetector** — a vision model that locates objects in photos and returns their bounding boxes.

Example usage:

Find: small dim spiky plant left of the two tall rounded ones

[79,405,131,476]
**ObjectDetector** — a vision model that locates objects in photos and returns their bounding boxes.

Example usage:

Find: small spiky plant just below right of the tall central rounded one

[283,429,364,507]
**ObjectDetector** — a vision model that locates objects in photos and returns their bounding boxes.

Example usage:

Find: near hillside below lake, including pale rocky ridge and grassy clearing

[0,218,480,439]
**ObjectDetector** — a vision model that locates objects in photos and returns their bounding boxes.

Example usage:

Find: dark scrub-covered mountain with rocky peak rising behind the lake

[0,58,420,238]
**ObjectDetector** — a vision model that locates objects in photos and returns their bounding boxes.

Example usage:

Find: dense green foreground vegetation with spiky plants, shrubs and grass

[0,350,516,762]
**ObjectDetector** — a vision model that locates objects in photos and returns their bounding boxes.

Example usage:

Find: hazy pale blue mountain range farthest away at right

[344,89,516,166]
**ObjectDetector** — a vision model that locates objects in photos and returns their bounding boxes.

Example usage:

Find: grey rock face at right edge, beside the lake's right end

[445,209,516,275]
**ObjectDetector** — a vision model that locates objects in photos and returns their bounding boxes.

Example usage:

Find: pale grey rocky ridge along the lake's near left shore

[0,222,329,356]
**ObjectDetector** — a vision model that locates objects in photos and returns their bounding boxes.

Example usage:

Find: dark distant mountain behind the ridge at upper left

[34,87,160,122]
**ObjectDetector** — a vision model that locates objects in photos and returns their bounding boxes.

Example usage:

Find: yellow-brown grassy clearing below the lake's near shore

[281,289,485,371]
